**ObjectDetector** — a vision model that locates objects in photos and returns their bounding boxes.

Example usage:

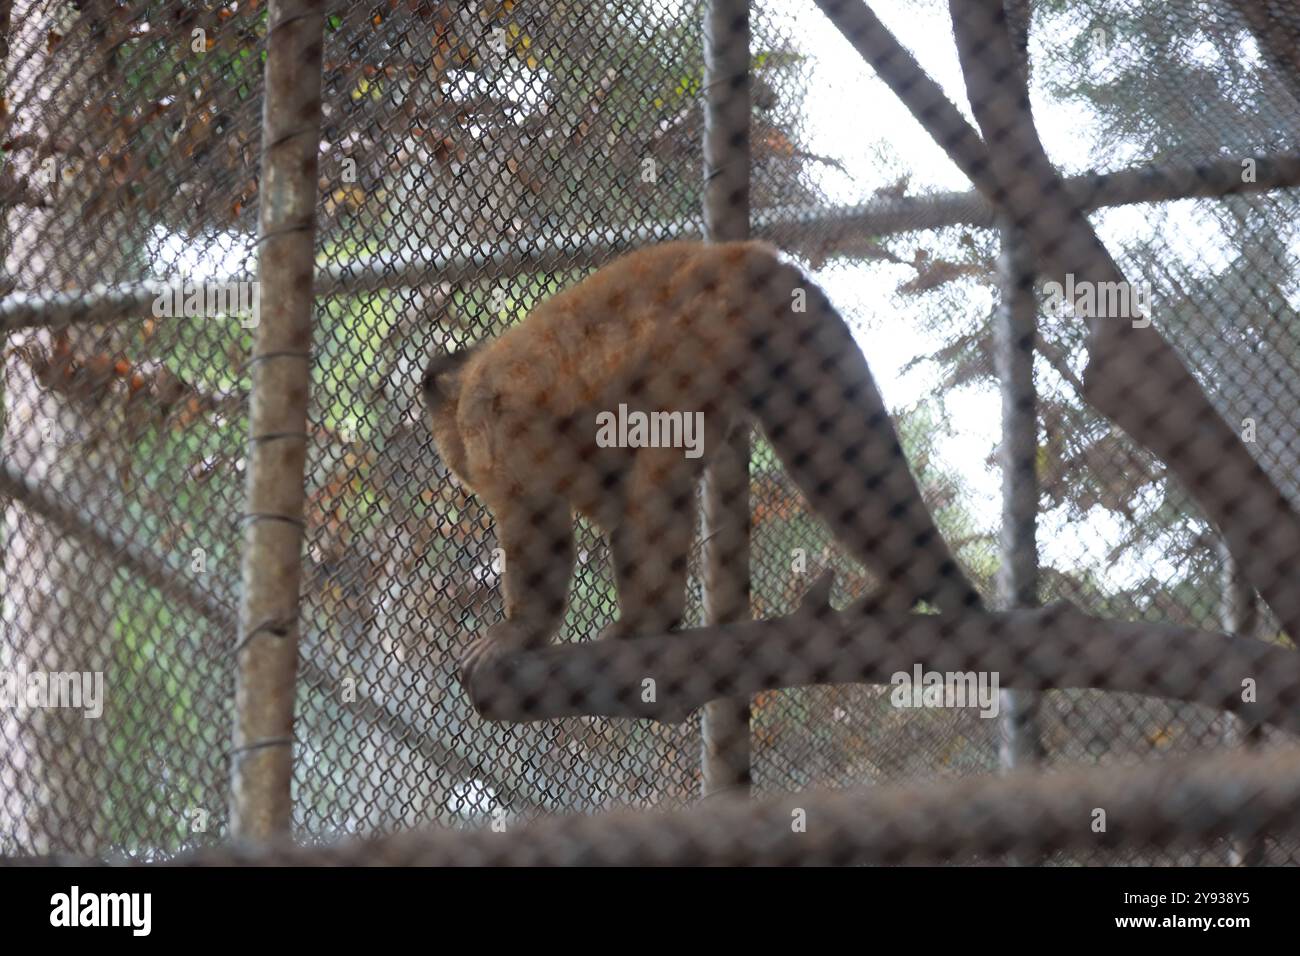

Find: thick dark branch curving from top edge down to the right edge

[949,0,1300,647]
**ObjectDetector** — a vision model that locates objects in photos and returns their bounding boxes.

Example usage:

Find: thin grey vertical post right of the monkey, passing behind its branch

[993,222,1045,790]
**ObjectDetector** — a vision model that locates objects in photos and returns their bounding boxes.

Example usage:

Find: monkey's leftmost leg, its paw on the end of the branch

[460,499,573,684]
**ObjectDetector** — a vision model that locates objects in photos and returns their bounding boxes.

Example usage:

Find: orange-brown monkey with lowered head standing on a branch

[421,241,980,685]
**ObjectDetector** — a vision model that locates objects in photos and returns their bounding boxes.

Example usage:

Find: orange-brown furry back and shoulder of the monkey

[459,241,777,494]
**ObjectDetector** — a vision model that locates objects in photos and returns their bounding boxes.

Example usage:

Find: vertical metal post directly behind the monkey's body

[699,0,750,797]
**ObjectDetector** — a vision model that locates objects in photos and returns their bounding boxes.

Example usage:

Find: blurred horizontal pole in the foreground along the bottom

[111,748,1300,866]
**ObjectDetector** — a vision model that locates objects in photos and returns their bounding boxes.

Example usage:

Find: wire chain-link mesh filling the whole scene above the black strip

[0,0,1300,864]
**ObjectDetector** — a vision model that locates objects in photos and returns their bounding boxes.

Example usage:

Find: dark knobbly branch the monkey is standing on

[468,574,1300,732]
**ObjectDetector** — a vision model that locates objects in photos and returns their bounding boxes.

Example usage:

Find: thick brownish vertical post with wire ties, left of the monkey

[230,0,324,840]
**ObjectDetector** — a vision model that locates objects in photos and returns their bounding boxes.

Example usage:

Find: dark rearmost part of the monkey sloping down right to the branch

[744,250,982,611]
